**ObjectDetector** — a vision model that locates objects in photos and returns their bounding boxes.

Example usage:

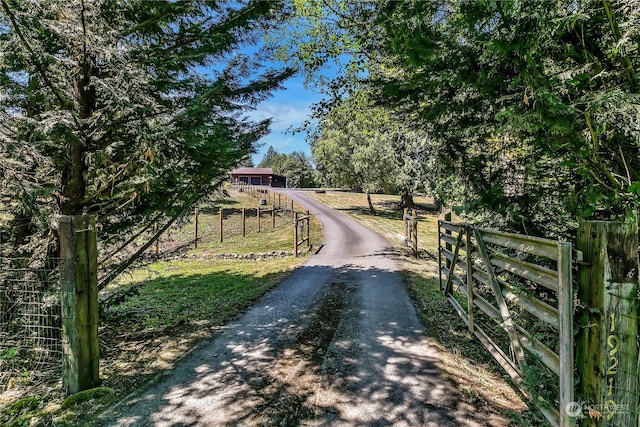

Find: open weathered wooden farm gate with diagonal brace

[438,221,574,427]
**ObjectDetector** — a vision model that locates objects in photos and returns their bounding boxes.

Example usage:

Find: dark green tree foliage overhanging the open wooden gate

[370,0,640,234]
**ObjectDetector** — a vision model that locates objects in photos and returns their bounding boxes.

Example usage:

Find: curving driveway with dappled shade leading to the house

[101,192,473,426]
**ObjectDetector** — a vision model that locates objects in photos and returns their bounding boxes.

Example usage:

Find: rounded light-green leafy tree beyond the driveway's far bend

[312,91,459,212]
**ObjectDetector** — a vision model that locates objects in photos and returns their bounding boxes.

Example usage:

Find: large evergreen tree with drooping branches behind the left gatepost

[0,0,290,284]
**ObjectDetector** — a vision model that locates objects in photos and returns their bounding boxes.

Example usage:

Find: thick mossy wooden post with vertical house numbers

[572,221,639,426]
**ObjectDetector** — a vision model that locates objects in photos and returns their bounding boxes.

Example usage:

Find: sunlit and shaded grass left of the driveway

[0,192,322,427]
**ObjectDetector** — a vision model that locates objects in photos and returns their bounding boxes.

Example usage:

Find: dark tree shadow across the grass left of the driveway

[99,266,292,410]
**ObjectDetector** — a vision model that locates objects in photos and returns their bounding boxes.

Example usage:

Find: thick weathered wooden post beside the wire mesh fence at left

[59,216,100,394]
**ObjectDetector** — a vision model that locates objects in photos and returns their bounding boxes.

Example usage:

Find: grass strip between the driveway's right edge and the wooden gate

[310,191,546,426]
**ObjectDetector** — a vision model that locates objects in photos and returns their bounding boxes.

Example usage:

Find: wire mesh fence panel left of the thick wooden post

[0,258,62,393]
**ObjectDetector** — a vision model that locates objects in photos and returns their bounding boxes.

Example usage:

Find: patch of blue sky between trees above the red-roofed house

[250,75,322,164]
